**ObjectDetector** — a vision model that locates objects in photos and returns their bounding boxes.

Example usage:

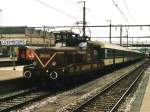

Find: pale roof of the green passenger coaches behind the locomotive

[88,41,141,53]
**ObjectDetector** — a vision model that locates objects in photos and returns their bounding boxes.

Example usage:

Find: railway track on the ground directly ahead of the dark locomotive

[0,88,50,112]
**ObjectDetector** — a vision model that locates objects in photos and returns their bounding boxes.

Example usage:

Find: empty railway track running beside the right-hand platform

[69,62,150,112]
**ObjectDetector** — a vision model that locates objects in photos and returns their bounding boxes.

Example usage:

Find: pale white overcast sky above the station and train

[0,0,150,43]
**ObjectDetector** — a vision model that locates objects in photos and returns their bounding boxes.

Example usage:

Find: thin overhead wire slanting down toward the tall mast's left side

[36,0,77,20]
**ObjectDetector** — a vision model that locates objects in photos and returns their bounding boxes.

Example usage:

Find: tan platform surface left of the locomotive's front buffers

[0,66,23,81]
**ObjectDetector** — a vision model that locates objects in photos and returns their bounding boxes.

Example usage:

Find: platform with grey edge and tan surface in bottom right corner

[129,67,150,112]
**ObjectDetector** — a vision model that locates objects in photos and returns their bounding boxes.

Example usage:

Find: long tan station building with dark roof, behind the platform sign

[0,26,55,56]
